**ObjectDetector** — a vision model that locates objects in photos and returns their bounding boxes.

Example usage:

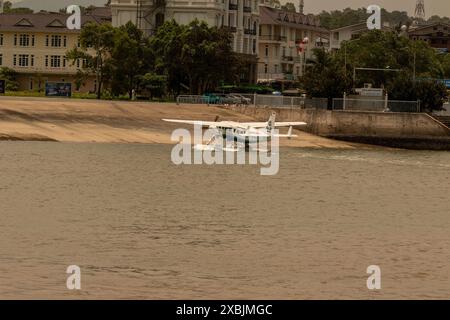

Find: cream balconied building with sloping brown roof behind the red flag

[258,4,328,82]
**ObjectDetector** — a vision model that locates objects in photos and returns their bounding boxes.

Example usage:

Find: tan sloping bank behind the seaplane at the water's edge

[0,97,366,149]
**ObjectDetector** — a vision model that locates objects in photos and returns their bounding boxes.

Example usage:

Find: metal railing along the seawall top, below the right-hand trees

[333,98,420,112]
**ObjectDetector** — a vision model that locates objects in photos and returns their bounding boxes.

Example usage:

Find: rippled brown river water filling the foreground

[0,142,450,299]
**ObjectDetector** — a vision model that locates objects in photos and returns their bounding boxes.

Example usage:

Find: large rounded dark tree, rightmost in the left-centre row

[150,20,237,94]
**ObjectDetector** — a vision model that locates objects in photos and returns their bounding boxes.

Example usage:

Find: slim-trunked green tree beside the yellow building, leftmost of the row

[66,23,116,99]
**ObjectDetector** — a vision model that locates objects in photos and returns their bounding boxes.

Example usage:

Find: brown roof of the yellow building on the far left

[0,8,109,33]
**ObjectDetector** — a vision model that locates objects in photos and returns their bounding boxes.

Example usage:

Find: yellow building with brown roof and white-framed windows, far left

[0,13,108,92]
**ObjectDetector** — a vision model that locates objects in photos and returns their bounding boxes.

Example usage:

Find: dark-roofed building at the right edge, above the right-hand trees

[408,23,450,53]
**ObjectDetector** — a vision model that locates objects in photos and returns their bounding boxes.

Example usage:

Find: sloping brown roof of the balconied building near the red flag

[259,6,328,32]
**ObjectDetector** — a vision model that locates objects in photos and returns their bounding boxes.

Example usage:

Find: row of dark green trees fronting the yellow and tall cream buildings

[67,20,243,98]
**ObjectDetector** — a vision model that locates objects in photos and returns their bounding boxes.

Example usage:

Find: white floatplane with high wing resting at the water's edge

[162,112,306,152]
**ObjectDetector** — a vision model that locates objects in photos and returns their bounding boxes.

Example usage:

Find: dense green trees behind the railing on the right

[301,30,450,110]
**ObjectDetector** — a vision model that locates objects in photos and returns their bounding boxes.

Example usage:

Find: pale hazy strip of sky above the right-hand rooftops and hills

[288,0,450,17]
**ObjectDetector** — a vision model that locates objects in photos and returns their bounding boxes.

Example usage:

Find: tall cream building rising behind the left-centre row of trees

[111,0,259,82]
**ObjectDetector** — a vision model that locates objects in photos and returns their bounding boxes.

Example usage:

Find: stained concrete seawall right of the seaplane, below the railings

[227,106,450,150]
